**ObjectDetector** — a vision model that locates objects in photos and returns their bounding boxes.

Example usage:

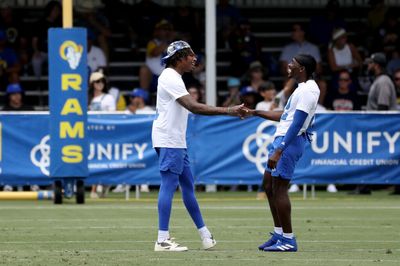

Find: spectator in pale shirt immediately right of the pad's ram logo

[87,29,108,72]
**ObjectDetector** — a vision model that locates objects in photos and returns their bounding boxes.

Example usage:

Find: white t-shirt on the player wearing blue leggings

[152,68,189,148]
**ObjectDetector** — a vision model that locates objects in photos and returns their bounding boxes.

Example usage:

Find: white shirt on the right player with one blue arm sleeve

[275,80,319,137]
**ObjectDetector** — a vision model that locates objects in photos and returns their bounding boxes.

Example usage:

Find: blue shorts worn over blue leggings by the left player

[155,148,190,175]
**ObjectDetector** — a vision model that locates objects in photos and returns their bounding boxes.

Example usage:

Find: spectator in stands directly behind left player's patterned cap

[139,19,174,91]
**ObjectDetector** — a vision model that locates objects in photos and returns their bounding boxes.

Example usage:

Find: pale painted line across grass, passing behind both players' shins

[0,205,400,211]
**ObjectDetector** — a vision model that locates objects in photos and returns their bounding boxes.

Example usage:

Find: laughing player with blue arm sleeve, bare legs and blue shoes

[247,54,320,252]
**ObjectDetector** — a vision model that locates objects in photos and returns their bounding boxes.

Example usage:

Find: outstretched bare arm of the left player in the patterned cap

[177,94,243,116]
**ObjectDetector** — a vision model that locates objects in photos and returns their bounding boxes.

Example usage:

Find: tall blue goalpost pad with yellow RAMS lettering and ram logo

[48,28,88,178]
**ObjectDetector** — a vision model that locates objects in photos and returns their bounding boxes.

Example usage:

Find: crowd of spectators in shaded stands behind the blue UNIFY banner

[0,0,400,197]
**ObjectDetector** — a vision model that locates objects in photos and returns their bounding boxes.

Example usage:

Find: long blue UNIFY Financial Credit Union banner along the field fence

[0,113,400,185]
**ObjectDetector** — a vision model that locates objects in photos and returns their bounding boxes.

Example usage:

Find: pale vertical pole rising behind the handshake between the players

[205,0,217,106]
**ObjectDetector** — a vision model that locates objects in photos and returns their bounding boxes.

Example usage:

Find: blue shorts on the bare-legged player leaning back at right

[265,134,307,180]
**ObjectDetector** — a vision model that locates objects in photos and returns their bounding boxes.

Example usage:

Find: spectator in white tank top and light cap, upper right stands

[328,28,362,73]
